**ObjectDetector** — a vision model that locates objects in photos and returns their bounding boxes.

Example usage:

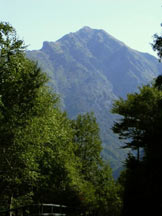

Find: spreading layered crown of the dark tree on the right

[112,86,161,159]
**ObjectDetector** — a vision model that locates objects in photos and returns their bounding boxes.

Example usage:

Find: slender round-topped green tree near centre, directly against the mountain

[72,113,102,180]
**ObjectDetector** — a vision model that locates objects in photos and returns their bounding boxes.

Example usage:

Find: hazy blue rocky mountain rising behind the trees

[27,27,162,176]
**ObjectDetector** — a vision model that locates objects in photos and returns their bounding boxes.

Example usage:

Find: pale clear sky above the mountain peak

[0,0,162,55]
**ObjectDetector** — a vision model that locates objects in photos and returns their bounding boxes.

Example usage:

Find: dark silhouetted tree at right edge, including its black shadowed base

[112,82,162,215]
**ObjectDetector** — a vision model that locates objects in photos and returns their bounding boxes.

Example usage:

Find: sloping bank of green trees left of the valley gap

[0,22,121,216]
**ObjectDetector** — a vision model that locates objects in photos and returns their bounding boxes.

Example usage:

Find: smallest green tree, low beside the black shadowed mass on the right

[93,163,122,216]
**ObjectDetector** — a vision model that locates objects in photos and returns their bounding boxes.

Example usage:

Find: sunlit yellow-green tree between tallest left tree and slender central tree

[34,109,81,205]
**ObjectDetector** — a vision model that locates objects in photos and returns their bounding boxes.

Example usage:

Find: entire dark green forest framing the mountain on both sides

[0,22,162,216]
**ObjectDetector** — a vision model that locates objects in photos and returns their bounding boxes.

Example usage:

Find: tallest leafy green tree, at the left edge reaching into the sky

[0,22,57,211]
